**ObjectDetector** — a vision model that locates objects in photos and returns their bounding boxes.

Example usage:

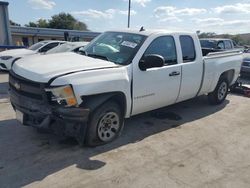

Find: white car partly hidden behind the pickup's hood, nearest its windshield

[45,42,88,55]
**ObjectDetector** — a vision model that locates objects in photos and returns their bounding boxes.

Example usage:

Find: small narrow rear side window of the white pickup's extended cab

[180,35,196,63]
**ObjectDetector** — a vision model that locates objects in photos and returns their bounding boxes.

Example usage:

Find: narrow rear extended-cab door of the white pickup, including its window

[177,35,203,102]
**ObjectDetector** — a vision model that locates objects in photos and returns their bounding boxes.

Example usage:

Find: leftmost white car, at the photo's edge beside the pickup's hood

[0,40,65,70]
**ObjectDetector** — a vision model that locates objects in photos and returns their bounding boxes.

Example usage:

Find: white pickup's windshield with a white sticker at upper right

[84,32,146,65]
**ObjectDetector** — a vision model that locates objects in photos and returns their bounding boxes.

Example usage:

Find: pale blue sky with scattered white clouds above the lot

[5,0,250,34]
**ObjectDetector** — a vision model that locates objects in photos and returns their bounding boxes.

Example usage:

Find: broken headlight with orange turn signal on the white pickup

[46,85,77,107]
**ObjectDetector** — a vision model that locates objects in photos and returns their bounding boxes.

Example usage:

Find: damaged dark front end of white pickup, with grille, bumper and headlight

[9,71,89,140]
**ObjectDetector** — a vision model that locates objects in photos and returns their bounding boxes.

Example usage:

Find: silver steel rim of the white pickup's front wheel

[97,112,120,142]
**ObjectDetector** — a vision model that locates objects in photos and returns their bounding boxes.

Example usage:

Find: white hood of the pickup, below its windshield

[12,52,119,83]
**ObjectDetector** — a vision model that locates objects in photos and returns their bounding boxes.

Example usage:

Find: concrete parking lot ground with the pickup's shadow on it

[0,73,250,188]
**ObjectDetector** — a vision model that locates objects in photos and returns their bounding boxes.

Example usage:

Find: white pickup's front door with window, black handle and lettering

[132,36,181,115]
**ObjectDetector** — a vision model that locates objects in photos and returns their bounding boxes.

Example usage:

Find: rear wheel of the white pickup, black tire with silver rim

[208,77,229,105]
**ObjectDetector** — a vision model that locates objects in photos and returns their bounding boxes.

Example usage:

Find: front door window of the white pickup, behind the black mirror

[144,36,177,65]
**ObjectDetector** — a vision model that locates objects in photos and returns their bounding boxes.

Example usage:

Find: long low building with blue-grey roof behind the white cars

[10,26,100,46]
